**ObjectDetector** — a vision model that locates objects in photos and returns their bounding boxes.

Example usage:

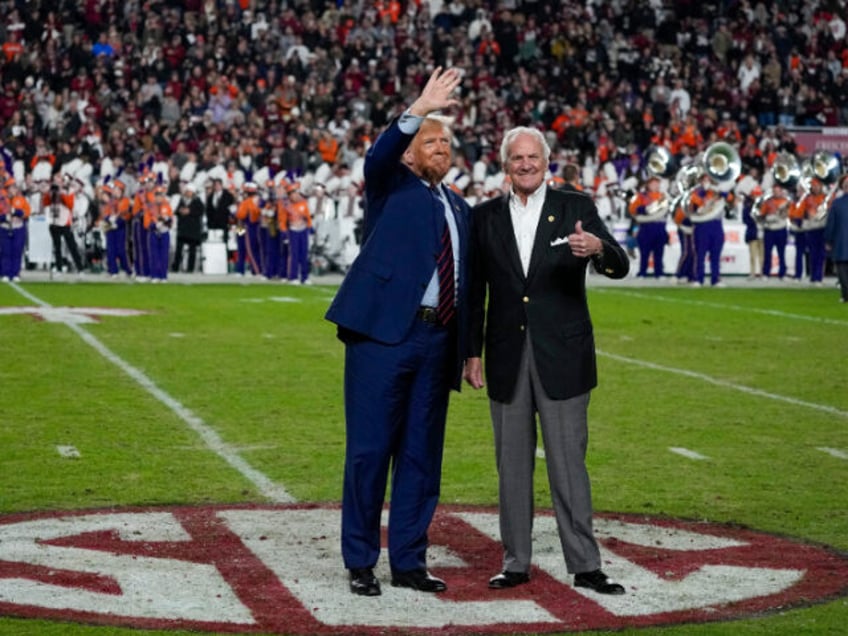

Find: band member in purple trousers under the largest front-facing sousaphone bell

[689,174,733,287]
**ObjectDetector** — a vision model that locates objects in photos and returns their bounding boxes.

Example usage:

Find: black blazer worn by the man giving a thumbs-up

[469,188,630,402]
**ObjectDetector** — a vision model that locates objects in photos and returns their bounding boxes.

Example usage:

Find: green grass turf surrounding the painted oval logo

[0,283,848,635]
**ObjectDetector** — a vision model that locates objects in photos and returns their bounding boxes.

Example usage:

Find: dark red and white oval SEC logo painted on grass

[0,505,848,634]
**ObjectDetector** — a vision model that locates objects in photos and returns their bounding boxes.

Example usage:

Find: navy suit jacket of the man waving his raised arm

[326,120,471,389]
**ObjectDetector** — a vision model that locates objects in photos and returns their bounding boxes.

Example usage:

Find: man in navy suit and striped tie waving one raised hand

[326,68,470,596]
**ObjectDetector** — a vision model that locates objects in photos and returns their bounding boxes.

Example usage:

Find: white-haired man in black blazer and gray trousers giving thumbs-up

[465,127,629,594]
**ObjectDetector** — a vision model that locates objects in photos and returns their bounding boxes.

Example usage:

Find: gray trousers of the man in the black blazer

[489,336,601,573]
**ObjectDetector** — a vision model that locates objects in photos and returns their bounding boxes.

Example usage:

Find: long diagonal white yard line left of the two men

[12,283,296,503]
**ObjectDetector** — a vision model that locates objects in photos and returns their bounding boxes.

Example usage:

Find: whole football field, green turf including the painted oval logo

[0,276,848,636]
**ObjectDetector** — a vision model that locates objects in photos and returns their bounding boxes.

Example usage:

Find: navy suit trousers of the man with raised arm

[342,320,455,572]
